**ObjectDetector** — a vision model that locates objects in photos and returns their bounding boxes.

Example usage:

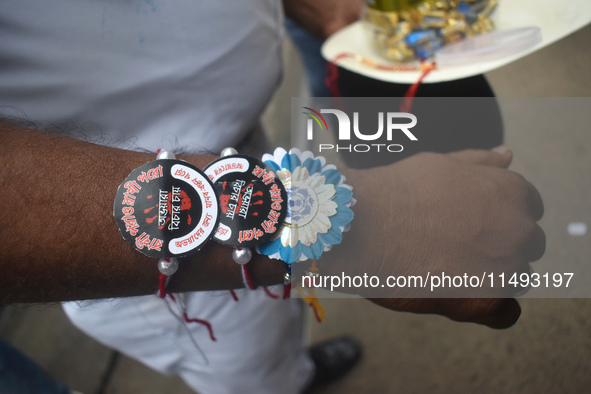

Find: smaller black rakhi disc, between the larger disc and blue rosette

[203,155,287,247]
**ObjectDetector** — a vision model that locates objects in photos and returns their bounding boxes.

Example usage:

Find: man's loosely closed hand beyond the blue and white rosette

[322,147,545,328]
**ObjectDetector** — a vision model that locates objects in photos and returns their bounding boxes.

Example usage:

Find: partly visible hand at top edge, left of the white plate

[283,0,364,39]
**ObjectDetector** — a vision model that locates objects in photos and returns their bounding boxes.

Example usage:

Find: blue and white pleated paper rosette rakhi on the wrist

[257,148,355,264]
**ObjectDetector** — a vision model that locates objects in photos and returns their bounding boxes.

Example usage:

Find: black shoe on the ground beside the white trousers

[304,336,361,394]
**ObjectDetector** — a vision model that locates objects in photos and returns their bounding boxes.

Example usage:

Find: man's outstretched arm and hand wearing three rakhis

[0,121,545,328]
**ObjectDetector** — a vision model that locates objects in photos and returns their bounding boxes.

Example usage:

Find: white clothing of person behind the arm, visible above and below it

[0,0,312,394]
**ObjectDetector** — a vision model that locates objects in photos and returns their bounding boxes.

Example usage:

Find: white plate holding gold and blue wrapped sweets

[322,0,591,83]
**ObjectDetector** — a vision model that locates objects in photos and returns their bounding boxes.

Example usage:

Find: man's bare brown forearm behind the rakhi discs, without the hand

[0,123,284,303]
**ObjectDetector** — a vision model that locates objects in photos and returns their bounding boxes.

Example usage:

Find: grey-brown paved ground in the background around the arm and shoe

[0,22,591,394]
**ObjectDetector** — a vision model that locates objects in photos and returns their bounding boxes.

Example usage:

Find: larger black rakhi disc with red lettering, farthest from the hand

[113,160,220,258]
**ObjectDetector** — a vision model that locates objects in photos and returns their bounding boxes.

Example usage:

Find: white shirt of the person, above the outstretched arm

[0,0,282,151]
